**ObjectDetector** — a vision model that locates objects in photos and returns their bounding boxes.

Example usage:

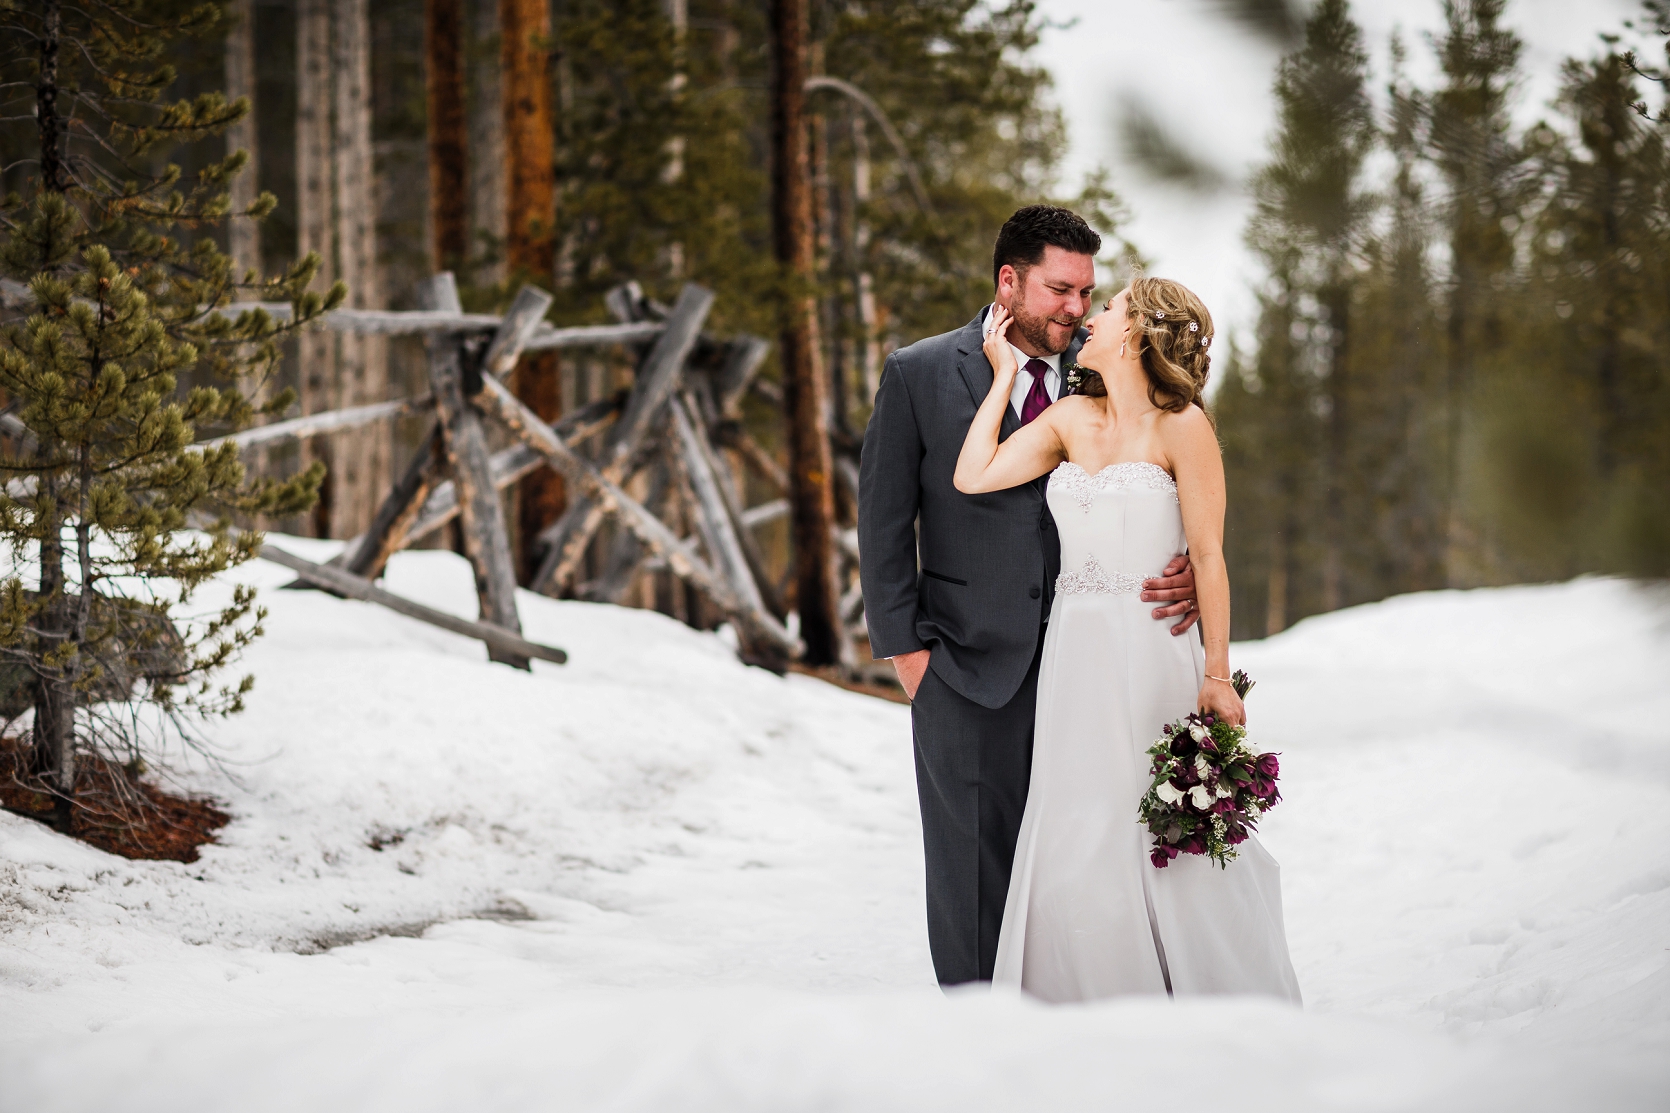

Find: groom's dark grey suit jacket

[858,313,1084,707]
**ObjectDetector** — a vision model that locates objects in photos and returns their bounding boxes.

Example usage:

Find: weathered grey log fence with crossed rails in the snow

[0,272,814,668]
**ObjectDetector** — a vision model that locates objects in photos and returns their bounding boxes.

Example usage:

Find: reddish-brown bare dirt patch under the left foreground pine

[0,739,232,862]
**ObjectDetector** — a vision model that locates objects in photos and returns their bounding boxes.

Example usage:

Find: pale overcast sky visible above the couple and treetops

[1040,0,1657,340]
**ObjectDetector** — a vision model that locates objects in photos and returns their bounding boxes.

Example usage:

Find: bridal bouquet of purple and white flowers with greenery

[1137,670,1281,869]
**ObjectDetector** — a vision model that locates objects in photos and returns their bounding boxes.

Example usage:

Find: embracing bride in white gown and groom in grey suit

[858,206,1299,1001]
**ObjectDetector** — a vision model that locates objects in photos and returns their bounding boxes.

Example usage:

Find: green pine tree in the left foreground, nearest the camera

[0,0,332,827]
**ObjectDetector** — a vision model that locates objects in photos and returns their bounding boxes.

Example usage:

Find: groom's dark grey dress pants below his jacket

[910,630,1044,986]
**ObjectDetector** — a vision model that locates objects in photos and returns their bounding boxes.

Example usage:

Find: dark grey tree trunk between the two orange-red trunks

[464,0,506,286]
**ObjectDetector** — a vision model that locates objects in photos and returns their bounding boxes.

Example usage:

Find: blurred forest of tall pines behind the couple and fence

[0,0,1670,637]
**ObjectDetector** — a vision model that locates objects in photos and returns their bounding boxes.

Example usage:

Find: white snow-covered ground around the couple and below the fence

[0,540,1670,1113]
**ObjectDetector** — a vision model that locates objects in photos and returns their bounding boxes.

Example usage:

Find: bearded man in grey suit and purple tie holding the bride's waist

[858,206,1199,986]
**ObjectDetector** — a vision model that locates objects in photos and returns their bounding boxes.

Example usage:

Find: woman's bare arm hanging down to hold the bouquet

[1161,406,1246,725]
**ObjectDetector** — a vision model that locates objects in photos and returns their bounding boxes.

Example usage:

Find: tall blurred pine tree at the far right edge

[1529,53,1670,575]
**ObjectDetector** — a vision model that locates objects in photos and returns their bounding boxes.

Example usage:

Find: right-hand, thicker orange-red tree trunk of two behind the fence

[499,0,568,583]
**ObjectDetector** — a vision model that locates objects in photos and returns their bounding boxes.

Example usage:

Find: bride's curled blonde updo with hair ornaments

[1082,277,1212,413]
